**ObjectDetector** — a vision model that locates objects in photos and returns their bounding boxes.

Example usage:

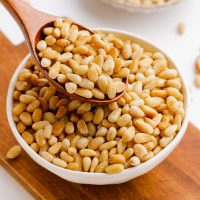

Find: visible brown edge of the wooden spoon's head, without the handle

[32,17,128,105]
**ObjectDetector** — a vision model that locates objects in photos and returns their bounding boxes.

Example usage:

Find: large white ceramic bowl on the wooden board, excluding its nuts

[6,28,190,185]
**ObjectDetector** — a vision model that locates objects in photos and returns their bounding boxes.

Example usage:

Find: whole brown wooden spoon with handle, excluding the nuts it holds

[0,0,128,105]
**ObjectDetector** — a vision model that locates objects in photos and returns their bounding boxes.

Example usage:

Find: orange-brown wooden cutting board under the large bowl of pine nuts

[0,33,200,200]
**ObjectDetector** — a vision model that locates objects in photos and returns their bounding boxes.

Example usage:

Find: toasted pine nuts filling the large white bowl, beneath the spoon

[13,32,185,173]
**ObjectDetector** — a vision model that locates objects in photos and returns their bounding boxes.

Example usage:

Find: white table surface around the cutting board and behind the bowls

[0,0,200,200]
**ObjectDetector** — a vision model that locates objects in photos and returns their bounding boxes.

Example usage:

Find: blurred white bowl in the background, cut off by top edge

[101,0,184,13]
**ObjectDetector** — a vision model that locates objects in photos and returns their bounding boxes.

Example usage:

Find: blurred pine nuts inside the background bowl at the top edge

[108,0,176,7]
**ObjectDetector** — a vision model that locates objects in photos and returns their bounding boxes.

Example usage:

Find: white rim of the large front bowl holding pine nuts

[6,28,191,178]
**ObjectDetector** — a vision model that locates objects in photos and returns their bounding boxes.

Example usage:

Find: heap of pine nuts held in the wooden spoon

[37,18,128,99]
